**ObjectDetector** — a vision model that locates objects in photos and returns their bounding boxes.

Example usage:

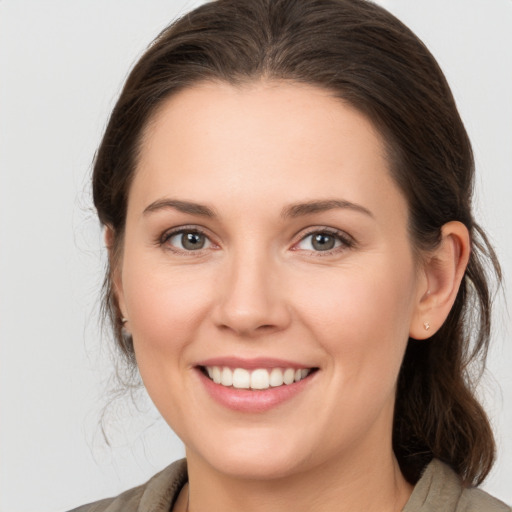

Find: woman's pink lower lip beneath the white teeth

[197,369,317,413]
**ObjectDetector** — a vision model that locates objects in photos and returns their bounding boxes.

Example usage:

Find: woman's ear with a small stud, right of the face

[409,221,471,340]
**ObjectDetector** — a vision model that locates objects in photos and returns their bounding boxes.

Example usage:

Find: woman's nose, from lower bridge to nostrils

[214,249,291,338]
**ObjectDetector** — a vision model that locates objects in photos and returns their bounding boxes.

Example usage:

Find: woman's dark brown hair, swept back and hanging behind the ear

[93,0,501,485]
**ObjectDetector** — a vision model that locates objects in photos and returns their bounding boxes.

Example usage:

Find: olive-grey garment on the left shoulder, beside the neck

[69,459,187,512]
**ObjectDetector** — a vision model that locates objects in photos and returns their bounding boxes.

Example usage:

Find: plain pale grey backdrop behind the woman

[0,0,512,512]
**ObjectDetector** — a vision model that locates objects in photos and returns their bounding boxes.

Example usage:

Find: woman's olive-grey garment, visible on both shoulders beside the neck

[69,459,512,512]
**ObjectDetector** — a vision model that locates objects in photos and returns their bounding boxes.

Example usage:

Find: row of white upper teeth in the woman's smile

[206,366,311,389]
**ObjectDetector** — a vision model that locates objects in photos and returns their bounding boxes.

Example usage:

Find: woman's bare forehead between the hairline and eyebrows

[133,81,404,222]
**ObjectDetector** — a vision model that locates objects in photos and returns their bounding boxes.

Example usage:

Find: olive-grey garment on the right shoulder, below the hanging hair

[403,459,512,512]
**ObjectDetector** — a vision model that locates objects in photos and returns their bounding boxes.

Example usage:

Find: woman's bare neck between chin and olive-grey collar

[176,442,412,512]
